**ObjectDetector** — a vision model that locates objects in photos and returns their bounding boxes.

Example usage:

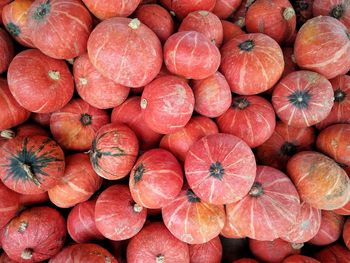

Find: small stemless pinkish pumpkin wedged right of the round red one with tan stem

[192,72,232,118]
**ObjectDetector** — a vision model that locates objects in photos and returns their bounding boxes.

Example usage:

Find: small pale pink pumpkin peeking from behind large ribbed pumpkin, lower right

[281,202,321,243]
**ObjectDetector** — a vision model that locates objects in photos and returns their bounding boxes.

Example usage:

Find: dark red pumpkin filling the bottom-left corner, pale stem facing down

[1,206,66,262]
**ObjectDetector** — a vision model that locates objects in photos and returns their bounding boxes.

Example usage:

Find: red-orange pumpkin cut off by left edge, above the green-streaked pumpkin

[0,78,30,131]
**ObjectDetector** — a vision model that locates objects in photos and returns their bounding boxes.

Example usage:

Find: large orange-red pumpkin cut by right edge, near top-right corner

[294,16,350,79]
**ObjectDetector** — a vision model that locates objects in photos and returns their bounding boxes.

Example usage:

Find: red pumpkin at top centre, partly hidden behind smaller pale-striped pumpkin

[179,10,223,47]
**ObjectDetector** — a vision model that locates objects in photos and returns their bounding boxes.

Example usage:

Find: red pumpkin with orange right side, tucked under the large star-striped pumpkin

[162,187,225,244]
